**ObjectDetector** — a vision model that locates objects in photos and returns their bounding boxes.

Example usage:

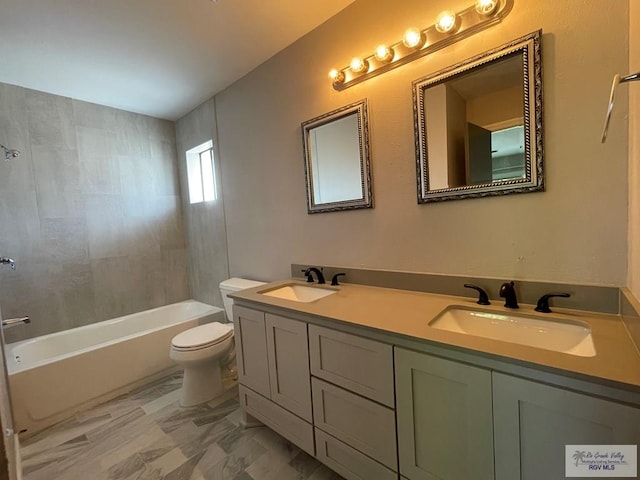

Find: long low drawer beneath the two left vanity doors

[239,385,315,456]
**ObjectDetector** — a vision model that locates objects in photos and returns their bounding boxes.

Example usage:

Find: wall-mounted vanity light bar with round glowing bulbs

[329,0,513,90]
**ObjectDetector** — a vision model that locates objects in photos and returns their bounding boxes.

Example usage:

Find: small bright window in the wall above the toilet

[187,140,218,203]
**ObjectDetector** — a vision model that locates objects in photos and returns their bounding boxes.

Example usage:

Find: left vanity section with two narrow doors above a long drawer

[233,305,314,455]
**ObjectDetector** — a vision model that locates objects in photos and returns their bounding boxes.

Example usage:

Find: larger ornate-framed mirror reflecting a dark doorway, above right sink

[413,31,544,203]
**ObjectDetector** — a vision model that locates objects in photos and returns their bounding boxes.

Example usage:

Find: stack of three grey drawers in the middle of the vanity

[309,325,398,480]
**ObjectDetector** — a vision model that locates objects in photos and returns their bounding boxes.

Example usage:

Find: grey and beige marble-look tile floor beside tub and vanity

[21,374,342,480]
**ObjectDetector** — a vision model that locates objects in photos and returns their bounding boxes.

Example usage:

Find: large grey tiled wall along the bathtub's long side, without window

[0,84,189,341]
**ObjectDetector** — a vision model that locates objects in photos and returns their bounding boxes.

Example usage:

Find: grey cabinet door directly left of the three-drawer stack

[266,314,312,422]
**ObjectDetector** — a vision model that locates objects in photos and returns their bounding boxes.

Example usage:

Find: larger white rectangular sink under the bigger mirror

[429,306,596,357]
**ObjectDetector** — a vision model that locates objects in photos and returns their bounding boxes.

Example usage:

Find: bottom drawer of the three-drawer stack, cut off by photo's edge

[314,428,398,480]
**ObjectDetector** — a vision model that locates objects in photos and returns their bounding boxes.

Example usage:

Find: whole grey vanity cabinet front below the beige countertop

[234,305,640,480]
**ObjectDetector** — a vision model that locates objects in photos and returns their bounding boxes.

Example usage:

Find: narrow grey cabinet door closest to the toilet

[233,305,270,398]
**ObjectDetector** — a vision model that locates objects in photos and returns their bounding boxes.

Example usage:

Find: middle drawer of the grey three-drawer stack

[311,378,398,471]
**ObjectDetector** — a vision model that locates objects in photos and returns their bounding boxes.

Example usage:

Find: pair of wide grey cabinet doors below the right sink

[395,347,640,480]
